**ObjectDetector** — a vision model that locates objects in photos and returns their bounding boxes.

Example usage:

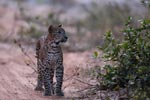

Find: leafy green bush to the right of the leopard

[96,17,150,100]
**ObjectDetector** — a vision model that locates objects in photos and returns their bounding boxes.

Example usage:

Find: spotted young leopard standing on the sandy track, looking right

[35,25,68,96]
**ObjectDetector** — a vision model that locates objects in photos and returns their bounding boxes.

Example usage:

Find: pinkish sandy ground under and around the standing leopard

[0,43,99,100]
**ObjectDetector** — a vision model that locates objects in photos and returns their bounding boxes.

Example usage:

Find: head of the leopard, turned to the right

[48,25,68,44]
